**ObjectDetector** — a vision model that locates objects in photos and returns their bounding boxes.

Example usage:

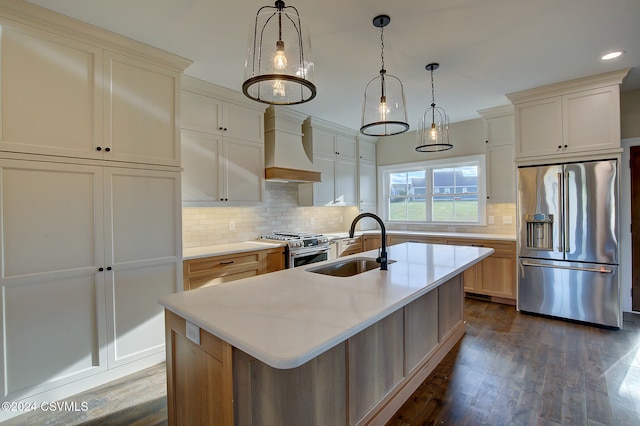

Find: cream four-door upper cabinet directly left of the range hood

[182,77,264,207]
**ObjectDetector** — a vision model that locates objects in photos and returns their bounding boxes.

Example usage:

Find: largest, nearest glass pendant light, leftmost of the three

[242,0,316,105]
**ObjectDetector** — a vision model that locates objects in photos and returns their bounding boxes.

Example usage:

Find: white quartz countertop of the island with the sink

[159,243,493,369]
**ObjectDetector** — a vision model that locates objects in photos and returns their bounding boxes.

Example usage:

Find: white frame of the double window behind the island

[378,154,487,226]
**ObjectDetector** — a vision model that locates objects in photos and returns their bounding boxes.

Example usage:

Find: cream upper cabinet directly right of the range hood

[298,117,357,206]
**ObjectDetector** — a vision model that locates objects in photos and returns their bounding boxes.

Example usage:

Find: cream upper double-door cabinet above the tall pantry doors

[0,25,185,166]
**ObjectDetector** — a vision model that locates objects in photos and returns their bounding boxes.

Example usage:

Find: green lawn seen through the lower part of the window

[389,200,478,222]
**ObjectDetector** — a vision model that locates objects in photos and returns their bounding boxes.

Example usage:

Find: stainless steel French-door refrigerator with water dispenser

[517,160,622,328]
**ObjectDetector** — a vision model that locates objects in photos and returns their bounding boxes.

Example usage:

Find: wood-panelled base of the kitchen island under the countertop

[165,274,465,425]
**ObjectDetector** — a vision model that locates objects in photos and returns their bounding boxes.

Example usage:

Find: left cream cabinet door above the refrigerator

[515,97,563,157]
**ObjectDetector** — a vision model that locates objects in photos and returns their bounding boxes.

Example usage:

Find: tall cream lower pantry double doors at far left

[0,159,182,401]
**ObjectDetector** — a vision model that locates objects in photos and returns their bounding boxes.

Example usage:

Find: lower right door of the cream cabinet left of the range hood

[222,138,264,202]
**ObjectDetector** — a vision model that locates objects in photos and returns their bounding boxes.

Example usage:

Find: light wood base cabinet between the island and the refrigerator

[447,238,516,304]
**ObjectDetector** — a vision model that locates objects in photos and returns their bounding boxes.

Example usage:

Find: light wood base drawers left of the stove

[183,246,286,290]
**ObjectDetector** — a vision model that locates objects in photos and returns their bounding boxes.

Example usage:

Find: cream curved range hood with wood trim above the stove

[264,105,320,182]
